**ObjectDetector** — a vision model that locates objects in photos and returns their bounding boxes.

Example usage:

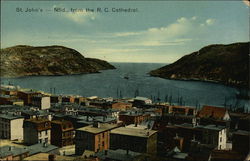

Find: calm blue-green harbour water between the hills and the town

[2,63,249,108]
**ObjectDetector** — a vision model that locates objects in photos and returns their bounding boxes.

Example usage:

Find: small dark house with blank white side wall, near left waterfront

[31,94,50,110]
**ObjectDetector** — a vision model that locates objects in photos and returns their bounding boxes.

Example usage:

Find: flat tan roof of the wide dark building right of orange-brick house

[111,127,157,137]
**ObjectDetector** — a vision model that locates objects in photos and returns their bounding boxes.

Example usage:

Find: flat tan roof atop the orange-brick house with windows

[77,124,118,134]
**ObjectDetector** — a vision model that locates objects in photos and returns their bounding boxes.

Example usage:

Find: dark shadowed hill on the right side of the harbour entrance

[150,42,250,88]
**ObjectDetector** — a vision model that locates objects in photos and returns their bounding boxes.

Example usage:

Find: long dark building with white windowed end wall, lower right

[162,123,227,151]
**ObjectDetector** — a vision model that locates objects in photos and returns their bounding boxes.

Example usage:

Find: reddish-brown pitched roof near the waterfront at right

[198,106,227,119]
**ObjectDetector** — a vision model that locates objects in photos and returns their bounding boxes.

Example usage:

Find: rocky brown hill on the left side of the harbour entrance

[0,45,115,77]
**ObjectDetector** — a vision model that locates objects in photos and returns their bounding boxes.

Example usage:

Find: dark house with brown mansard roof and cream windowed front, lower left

[23,118,51,145]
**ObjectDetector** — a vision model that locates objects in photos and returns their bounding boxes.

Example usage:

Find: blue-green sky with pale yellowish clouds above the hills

[1,1,249,63]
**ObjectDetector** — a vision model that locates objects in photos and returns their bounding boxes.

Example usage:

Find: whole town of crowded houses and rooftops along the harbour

[0,86,250,161]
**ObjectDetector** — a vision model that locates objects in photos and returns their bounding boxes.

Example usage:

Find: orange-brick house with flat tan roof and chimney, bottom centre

[75,122,117,155]
